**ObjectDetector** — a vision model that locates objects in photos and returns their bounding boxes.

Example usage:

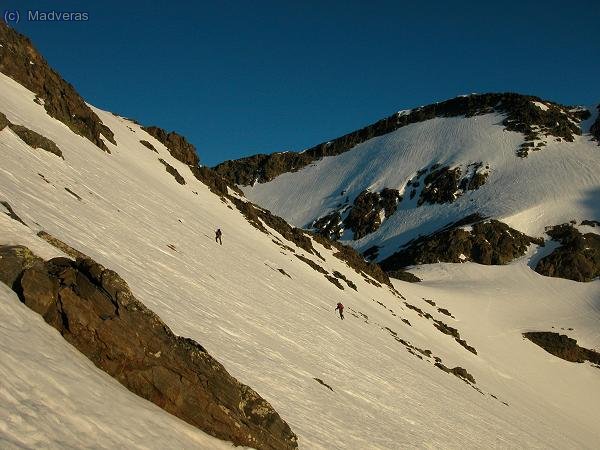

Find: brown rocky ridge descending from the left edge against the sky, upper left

[0,20,116,152]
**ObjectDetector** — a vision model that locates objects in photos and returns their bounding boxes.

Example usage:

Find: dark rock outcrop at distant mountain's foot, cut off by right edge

[535,224,600,281]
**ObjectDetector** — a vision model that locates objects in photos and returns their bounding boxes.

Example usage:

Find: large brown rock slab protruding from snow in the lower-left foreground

[0,246,297,449]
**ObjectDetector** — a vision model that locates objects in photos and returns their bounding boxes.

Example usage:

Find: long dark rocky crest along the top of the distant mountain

[215,92,590,186]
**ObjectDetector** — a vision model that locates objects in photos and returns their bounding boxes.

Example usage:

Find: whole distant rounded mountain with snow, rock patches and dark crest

[227,94,600,278]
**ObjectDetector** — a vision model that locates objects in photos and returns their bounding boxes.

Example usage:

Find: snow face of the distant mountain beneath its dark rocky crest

[243,108,600,260]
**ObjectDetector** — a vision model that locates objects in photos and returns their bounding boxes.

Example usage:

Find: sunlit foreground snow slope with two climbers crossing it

[0,75,600,449]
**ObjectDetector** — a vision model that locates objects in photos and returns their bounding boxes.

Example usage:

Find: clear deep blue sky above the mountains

[1,0,600,165]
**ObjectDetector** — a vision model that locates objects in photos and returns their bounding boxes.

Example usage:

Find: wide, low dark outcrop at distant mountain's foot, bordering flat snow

[380,215,543,272]
